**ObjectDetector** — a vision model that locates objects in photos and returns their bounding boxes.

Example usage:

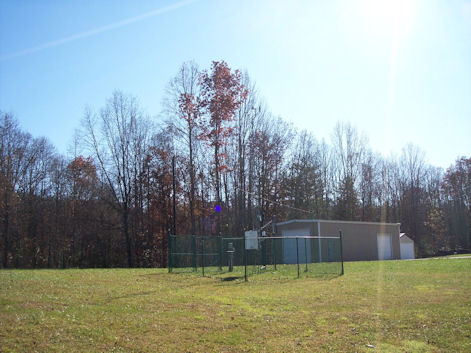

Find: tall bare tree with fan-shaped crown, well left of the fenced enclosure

[83,91,149,267]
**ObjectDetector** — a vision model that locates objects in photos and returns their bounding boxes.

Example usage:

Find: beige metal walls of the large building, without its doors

[278,220,401,261]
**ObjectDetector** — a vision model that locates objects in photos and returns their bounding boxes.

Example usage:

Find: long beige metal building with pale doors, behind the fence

[276,219,401,263]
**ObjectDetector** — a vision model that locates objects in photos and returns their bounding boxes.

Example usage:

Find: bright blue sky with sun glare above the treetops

[0,0,471,168]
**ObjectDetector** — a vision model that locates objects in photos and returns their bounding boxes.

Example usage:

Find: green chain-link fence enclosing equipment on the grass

[168,234,343,280]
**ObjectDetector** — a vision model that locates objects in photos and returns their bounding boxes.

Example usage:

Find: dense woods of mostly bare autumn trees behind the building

[0,62,471,268]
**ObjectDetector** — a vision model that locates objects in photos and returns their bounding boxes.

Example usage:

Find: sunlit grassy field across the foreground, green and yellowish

[0,259,471,352]
